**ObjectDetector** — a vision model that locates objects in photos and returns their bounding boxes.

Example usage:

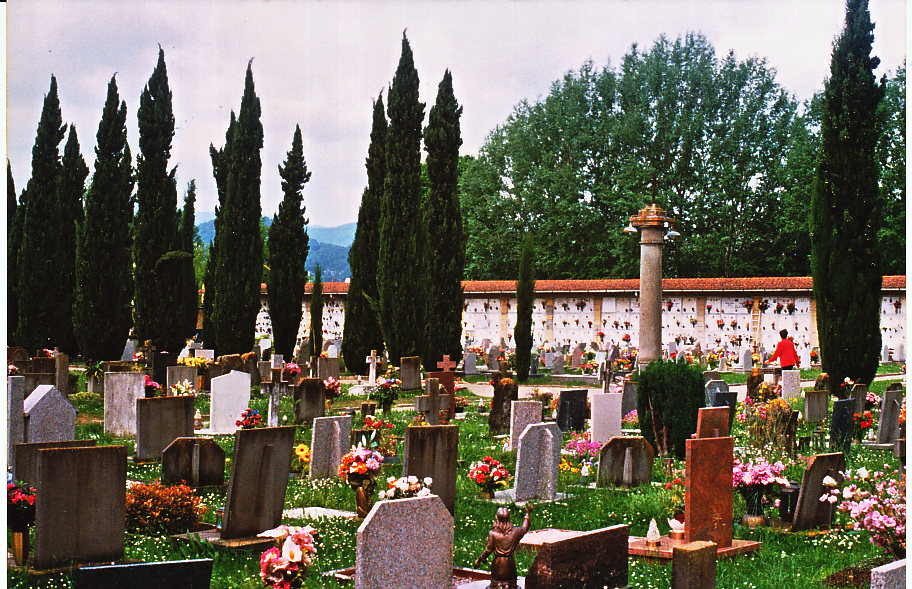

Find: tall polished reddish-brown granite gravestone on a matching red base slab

[684,437,735,548]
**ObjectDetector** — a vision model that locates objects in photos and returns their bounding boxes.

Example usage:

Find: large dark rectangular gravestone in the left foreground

[31,446,127,570]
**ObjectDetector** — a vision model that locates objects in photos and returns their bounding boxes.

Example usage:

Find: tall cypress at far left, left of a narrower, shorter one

[18,76,66,350]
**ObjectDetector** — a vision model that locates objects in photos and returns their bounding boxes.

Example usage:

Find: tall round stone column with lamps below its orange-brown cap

[624,201,681,366]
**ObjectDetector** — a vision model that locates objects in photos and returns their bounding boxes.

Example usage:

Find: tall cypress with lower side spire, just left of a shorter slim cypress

[212,63,263,355]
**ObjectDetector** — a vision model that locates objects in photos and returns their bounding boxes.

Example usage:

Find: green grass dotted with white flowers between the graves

[7,372,901,589]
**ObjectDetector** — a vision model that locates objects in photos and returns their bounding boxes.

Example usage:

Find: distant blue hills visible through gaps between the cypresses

[196,216,357,282]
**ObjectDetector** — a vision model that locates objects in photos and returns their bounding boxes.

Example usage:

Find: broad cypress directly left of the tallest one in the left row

[73,77,133,360]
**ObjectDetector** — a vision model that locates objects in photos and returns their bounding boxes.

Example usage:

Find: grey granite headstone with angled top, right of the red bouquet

[514,422,563,501]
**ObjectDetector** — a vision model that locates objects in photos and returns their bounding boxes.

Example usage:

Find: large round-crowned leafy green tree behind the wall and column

[460,34,797,279]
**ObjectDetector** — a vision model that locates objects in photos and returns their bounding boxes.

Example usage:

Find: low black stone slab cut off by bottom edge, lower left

[73,558,212,589]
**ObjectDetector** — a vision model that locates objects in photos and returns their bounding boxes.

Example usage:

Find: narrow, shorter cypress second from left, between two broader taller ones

[54,125,89,354]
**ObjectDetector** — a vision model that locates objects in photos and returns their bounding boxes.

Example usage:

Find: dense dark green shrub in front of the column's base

[637,359,703,459]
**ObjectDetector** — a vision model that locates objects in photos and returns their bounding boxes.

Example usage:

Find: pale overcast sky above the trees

[6,0,906,226]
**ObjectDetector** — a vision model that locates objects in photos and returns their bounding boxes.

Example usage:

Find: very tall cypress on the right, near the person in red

[810,0,884,393]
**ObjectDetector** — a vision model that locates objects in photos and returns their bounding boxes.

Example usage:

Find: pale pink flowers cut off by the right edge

[820,468,906,558]
